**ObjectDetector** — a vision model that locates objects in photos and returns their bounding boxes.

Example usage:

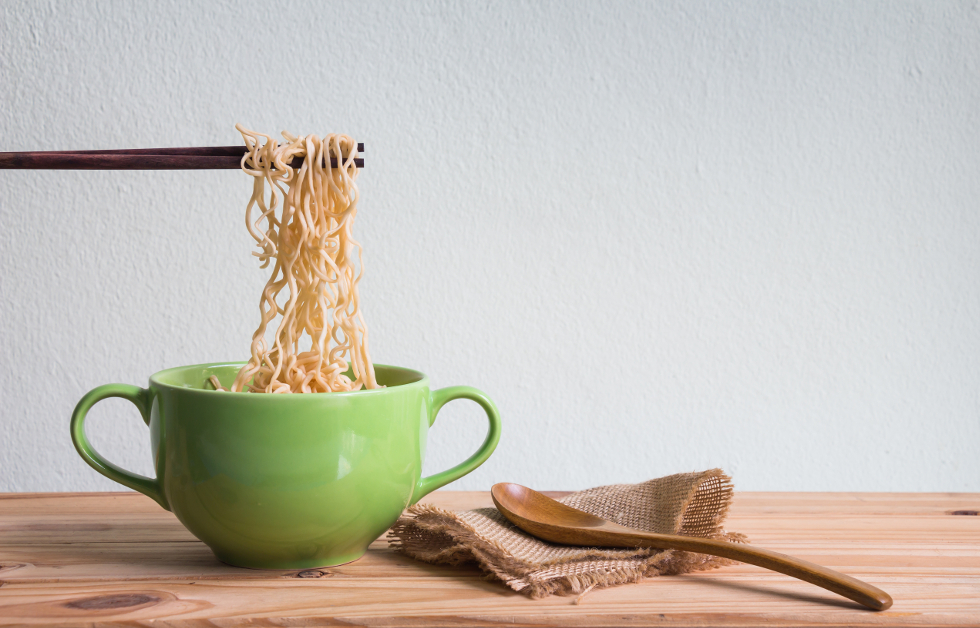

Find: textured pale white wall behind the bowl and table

[0,0,980,491]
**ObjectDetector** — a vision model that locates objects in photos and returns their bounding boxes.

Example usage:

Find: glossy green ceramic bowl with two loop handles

[71,363,500,569]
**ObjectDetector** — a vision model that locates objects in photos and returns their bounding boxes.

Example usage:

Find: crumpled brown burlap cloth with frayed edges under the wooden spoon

[388,469,745,598]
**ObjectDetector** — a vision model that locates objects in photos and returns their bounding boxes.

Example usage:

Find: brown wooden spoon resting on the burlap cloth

[490,483,892,611]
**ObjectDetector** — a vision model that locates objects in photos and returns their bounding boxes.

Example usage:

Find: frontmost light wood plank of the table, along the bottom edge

[0,576,978,626]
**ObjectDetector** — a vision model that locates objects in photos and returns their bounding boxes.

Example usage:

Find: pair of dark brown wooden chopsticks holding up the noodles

[0,144,364,170]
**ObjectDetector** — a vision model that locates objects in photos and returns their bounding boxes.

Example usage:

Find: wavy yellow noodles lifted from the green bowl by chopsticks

[231,125,378,393]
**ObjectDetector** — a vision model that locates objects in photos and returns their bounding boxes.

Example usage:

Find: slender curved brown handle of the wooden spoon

[615,528,892,611]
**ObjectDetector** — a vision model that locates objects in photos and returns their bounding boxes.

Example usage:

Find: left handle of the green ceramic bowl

[71,384,170,510]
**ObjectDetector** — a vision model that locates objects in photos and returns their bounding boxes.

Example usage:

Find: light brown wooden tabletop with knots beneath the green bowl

[0,491,980,626]
